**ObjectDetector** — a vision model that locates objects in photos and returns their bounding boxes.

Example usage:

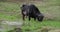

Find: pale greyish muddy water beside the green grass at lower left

[0,21,23,32]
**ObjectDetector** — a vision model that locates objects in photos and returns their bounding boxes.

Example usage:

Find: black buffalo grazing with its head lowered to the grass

[21,4,44,21]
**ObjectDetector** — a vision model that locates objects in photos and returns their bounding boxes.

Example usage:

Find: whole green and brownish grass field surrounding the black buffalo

[0,0,60,32]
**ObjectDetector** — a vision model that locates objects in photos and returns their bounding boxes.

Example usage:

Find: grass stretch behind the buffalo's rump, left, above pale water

[0,2,21,20]
